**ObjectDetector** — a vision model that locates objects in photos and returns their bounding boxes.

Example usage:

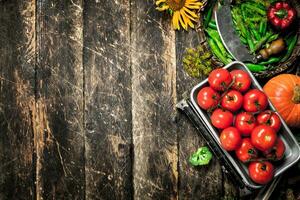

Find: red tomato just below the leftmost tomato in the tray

[210,108,233,129]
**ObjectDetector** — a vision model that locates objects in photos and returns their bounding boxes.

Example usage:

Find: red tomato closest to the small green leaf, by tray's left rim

[220,126,242,151]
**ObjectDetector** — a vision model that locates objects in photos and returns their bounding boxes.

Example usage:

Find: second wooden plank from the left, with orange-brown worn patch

[35,0,85,199]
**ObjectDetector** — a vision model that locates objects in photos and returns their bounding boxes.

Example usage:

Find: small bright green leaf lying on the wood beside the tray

[189,146,212,166]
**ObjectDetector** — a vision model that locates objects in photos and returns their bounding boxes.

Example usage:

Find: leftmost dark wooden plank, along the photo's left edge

[0,0,35,199]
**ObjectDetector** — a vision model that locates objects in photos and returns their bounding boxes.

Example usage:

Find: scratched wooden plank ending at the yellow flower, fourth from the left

[131,0,178,199]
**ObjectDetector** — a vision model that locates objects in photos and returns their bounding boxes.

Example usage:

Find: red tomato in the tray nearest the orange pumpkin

[243,89,268,112]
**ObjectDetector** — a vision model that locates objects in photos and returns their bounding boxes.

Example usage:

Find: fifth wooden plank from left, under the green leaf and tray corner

[176,30,223,199]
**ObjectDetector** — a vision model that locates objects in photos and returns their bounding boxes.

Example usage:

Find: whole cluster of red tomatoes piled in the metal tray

[197,69,285,184]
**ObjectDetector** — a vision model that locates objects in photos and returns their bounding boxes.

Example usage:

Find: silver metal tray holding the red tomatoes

[190,61,300,189]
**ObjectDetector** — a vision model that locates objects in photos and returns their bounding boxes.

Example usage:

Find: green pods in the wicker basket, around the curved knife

[204,0,298,72]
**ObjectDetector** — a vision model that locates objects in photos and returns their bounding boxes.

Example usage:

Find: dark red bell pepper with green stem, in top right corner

[268,1,297,29]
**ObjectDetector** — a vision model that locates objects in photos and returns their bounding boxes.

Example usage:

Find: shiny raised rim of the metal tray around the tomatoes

[190,61,300,189]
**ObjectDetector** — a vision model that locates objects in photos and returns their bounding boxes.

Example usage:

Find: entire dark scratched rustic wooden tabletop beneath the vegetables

[0,0,300,199]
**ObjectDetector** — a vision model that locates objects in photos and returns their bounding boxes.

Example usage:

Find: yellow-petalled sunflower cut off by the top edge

[156,0,203,30]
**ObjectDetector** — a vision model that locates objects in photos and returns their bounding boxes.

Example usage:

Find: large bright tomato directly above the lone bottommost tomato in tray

[251,125,277,151]
